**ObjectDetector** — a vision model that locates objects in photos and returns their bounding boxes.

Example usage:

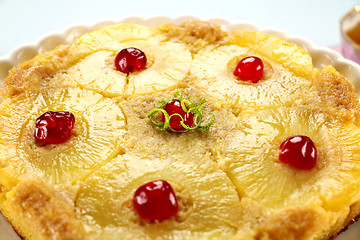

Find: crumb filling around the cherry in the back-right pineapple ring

[227,54,274,85]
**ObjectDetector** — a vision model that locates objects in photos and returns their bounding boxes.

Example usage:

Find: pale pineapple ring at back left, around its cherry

[61,24,192,95]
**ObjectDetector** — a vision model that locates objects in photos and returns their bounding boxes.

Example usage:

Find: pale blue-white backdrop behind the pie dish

[0,0,360,56]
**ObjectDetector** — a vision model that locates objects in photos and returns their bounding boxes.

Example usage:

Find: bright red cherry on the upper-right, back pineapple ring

[234,56,264,83]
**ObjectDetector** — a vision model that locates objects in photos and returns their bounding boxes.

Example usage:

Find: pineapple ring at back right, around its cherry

[191,45,312,108]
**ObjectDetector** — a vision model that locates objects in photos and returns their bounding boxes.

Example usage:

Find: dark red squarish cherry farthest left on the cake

[34,111,75,144]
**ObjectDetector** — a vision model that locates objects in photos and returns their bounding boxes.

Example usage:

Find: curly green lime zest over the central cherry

[148,92,215,132]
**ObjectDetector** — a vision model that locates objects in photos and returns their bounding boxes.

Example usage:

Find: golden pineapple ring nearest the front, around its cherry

[76,152,245,239]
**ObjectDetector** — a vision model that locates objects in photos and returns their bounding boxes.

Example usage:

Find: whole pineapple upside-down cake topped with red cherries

[0,21,360,240]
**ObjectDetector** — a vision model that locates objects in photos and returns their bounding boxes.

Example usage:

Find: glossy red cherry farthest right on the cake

[279,135,317,170]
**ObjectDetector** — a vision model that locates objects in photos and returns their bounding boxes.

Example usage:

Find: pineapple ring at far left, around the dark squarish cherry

[0,88,126,189]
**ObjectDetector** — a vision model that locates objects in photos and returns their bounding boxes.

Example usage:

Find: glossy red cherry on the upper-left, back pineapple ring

[114,47,147,74]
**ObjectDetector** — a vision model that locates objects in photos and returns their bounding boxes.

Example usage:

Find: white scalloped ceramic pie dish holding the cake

[0,16,360,240]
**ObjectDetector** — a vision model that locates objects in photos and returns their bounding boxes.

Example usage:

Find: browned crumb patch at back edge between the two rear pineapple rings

[158,21,227,53]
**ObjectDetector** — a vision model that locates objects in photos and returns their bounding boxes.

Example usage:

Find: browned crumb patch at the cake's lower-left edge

[8,182,85,240]
